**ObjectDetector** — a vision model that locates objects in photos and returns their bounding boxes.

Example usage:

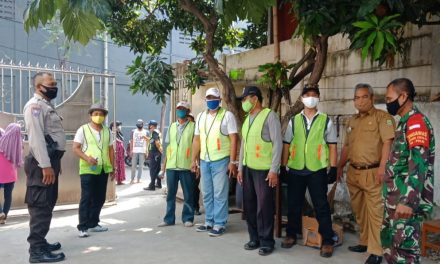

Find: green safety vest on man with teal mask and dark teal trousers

[166,122,195,170]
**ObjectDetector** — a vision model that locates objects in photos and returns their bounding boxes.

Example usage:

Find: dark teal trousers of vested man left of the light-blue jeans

[163,170,194,224]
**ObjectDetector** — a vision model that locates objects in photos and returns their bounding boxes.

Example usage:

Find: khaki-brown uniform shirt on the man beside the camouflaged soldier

[344,107,396,166]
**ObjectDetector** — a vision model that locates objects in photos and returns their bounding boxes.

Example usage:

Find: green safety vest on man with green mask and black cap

[241,108,272,170]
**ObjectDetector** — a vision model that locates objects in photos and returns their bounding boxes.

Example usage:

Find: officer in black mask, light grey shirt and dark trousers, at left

[23,72,66,263]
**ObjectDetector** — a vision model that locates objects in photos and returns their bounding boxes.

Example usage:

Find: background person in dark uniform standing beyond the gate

[144,120,162,191]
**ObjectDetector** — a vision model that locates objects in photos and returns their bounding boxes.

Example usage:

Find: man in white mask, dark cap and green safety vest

[280,85,337,258]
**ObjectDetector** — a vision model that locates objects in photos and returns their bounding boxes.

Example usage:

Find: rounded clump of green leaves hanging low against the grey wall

[127,55,174,104]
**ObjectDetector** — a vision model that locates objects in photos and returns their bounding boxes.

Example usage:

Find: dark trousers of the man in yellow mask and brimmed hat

[77,170,108,231]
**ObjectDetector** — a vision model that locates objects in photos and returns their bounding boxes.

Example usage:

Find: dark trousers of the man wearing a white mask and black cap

[286,169,334,245]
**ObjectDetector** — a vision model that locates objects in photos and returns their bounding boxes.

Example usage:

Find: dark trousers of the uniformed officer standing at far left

[24,155,61,252]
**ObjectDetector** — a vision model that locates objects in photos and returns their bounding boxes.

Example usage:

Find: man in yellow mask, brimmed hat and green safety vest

[73,103,114,238]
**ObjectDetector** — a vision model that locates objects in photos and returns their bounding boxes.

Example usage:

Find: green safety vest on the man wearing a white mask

[287,113,329,171]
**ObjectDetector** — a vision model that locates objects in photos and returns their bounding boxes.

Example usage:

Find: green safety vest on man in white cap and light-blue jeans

[198,108,231,161]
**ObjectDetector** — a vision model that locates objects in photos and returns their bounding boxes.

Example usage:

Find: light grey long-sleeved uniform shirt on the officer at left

[23,94,66,168]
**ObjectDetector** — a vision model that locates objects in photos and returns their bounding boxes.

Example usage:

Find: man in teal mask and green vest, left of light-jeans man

[159,101,195,227]
